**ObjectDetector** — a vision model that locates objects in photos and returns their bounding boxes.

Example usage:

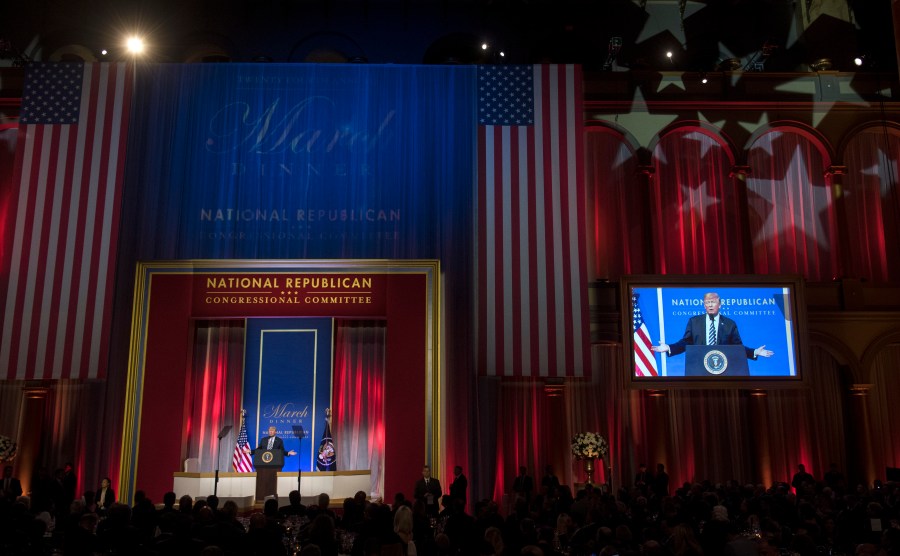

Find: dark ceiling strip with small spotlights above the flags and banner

[0,0,896,72]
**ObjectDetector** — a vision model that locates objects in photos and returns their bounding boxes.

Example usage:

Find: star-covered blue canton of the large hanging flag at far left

[20,63,84,124]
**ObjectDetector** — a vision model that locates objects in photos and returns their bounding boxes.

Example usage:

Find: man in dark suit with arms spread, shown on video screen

[650,292,774,360]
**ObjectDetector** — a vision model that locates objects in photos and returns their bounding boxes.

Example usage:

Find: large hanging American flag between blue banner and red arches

[476,65,590,377]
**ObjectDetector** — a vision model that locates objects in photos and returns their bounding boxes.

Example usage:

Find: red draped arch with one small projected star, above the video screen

[648,129,747,274]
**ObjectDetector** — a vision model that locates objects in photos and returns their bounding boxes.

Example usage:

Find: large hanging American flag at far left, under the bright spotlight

[0,63,133,379]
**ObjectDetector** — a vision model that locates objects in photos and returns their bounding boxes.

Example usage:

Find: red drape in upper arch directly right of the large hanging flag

[585,127,650,280]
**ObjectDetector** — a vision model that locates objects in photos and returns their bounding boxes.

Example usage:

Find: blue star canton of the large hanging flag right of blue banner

[478,65,534,125]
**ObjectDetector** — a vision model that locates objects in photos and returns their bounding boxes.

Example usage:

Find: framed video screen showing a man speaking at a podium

[623,277,801,383]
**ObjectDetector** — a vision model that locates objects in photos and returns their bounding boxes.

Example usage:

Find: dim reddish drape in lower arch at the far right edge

[868,344,900,478]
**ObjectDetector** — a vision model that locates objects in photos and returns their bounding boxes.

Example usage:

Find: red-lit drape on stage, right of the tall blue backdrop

[332,320,384,496]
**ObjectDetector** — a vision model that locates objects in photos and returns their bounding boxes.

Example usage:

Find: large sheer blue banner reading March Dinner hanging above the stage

[124,64,475,259]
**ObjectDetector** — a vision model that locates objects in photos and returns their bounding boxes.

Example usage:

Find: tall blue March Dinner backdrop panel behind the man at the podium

[243,319,334,471]
